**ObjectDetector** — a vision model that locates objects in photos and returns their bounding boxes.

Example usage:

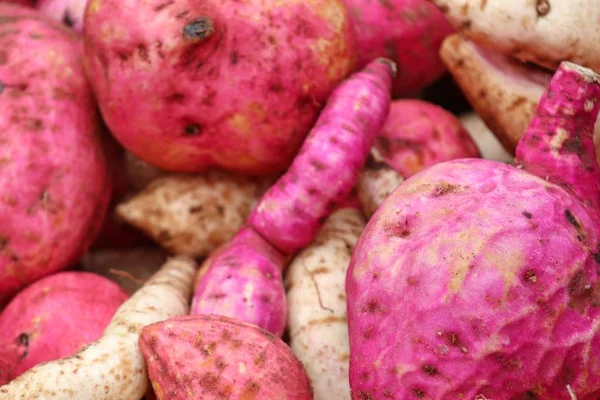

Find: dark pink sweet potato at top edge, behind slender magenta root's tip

[343,0,454,97]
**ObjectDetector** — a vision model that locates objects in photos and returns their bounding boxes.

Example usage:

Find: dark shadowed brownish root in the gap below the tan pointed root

[80,247,167,294]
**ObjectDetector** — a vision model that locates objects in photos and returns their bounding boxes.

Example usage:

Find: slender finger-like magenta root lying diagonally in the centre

[249,59,395,254]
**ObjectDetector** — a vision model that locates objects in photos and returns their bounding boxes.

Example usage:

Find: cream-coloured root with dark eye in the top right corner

[432,0,600,71]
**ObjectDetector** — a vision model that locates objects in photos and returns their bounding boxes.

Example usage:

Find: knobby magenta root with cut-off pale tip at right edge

[517,62,600,209]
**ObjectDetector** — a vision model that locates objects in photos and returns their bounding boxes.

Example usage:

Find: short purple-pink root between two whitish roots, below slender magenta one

[191,227,287,337]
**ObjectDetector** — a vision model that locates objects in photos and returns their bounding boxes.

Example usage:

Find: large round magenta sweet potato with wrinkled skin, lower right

[346,159,600,400]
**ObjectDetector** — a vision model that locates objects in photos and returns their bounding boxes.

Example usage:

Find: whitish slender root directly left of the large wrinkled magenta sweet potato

[285,208,365,400]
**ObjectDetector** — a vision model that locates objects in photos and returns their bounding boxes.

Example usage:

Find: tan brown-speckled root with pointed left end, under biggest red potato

[117,171,275,257]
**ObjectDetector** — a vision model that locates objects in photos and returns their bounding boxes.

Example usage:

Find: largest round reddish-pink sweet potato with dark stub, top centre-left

[85,0,356,174]
